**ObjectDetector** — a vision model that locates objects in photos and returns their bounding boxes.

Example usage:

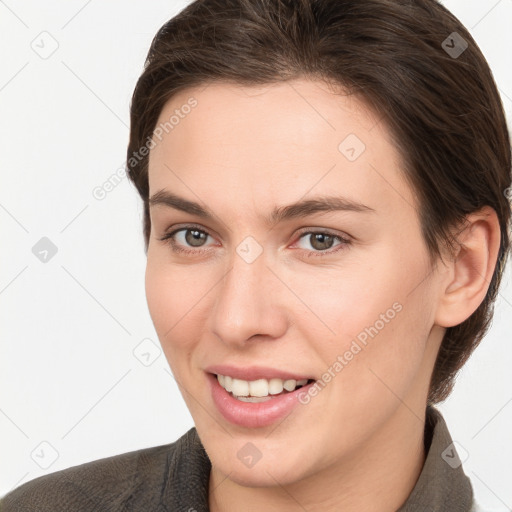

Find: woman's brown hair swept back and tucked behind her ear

[127,0,512,404]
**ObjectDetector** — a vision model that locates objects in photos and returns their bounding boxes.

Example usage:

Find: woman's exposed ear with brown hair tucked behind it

[435,206,501,327]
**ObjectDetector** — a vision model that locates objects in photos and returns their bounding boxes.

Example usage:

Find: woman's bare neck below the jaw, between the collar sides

[209,405,425,512]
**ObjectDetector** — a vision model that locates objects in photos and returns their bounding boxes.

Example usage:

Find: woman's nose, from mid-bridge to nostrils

[211,245,289,348]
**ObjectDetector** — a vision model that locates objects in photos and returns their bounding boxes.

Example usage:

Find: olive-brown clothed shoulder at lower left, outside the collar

[0,434,187,512]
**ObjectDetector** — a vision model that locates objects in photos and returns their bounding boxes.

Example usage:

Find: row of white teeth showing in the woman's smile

[217,375,308,402]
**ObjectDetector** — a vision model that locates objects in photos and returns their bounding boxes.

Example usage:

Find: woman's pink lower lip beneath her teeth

[207,373,314,428]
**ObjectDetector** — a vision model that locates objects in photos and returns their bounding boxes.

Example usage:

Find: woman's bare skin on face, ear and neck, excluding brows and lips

[146,79,499,512]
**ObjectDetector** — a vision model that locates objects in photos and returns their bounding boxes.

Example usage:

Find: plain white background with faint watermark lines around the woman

[0,0,512,510]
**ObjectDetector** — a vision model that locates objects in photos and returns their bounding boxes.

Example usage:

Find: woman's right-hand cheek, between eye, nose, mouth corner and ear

[288,244,432,384]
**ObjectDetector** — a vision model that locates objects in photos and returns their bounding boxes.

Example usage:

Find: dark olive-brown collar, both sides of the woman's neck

[162,406,473,512]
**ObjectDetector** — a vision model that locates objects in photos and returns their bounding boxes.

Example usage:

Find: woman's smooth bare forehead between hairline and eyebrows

[149,80,413,219]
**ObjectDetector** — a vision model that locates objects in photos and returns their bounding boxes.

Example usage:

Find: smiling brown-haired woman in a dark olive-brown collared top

[2,0,511,512]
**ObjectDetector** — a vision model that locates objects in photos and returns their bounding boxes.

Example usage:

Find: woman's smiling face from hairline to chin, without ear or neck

[146,80,442,486]
